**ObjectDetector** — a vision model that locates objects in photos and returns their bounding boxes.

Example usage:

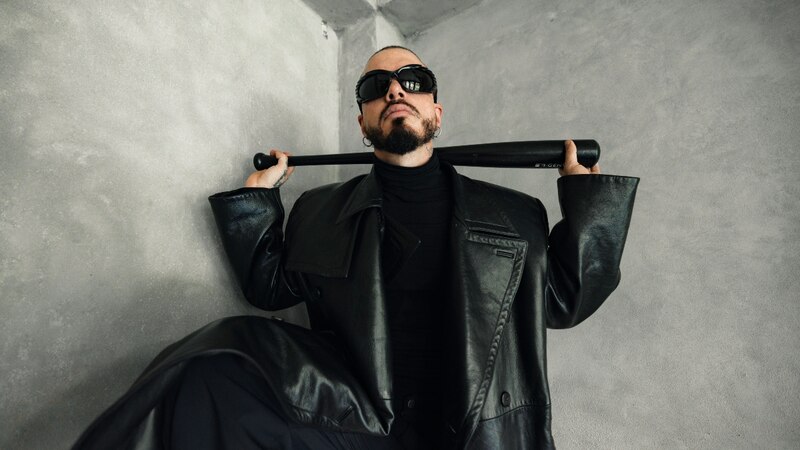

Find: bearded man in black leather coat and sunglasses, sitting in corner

[76,46,638,449]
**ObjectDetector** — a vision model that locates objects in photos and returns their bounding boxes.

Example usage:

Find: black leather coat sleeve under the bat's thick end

[545,175,639,328]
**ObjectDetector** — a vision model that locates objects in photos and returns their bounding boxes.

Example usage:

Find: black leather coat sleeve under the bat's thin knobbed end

[208,188,302,311]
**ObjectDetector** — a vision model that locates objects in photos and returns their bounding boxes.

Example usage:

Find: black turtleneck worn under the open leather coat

[375,154,453,446]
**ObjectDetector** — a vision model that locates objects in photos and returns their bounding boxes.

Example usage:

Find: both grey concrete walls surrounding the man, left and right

[0,0,800,449]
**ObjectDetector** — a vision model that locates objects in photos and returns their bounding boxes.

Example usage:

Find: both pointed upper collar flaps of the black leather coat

[336,161,520,237]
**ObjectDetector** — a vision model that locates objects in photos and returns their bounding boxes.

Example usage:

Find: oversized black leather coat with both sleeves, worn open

[75,164,639,450]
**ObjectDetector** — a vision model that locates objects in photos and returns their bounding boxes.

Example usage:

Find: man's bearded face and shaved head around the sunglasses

[358,48,442,155]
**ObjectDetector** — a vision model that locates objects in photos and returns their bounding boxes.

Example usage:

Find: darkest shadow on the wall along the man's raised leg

[8,279,214,449]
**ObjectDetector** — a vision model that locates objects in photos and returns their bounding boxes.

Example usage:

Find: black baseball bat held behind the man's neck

[253,139,600,170]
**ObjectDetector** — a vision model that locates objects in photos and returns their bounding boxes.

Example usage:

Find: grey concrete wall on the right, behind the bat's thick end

[408,0,800,449]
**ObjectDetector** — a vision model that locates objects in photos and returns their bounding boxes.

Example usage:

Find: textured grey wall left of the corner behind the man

[0,0,339,449]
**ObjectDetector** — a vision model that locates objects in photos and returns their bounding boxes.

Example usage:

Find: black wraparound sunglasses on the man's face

[356,64,437,108]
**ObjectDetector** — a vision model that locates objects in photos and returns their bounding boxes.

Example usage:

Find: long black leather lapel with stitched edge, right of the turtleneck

[445,169,528,445]
